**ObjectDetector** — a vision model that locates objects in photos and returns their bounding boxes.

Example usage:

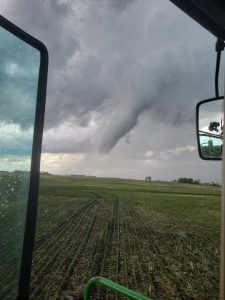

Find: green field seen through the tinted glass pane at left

[0,172,29,300]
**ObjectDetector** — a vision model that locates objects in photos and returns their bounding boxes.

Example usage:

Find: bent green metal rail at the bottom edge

[84,277,150,300]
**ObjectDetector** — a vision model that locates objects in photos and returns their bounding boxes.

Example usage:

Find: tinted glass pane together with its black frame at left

[0,16,48,300]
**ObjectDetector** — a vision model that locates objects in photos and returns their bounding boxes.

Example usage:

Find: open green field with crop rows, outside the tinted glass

[28,176,221,299]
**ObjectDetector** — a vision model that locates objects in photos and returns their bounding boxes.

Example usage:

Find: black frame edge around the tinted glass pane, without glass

[0,15,48,300]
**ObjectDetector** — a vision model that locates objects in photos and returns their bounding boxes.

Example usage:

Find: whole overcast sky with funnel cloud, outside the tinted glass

[1,0,223,181]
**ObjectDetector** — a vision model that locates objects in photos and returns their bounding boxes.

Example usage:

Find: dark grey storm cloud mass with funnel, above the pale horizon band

[1,0,214,153]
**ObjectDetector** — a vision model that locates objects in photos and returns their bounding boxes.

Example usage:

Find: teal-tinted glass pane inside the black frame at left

[0,27,40,299]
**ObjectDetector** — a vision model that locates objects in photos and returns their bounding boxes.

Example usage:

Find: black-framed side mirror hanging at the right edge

[196,97,224,160]
